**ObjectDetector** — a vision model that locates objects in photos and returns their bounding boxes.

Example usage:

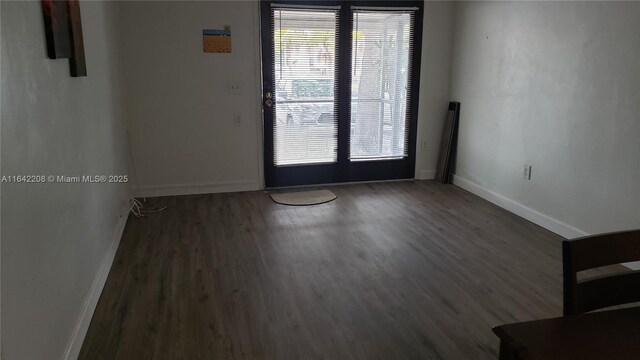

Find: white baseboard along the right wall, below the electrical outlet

[453,175,589,239]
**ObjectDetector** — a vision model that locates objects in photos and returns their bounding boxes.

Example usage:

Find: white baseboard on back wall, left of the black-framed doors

[133,181,260,197]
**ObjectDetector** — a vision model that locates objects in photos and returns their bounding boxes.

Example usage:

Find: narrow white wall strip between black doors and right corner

[416,1,454,179]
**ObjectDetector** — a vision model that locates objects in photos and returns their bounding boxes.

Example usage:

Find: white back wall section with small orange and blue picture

[121,1,262,196]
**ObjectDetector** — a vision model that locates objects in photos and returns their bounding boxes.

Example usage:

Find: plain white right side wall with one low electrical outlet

[451,2,640,237]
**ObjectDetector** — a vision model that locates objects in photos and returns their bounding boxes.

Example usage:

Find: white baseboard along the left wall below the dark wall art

[63,202,129,360]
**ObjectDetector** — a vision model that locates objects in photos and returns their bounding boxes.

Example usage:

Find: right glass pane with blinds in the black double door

[350,10,413,160]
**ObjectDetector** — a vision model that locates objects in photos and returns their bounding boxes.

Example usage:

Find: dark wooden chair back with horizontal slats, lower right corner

[562,230,640,316]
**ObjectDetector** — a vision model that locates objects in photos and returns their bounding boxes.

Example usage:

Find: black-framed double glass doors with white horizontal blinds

[262,1,422,187]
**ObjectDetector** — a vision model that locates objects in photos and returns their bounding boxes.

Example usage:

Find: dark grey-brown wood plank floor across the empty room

[80,181,562,360]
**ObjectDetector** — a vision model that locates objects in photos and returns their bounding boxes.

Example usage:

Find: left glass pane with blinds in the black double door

[272,8,338,165]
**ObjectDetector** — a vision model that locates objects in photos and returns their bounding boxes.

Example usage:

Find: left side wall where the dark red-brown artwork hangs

[0,1,129,359]
